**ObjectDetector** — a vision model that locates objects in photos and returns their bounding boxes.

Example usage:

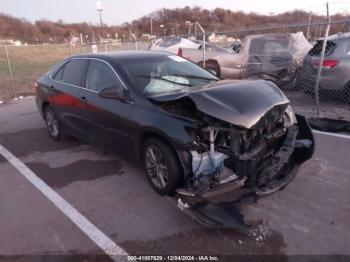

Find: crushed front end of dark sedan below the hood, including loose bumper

[177,105,314,226]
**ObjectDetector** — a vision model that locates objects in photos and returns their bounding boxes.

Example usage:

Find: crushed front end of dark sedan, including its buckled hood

[152,81,314,225]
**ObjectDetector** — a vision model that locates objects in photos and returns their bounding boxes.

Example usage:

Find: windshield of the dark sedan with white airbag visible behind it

[119,55,219,96]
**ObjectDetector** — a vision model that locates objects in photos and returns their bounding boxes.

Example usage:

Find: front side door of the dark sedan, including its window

[79,59,134,148]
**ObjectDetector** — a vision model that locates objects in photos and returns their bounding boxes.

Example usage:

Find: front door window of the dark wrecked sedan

[86,60,122,92]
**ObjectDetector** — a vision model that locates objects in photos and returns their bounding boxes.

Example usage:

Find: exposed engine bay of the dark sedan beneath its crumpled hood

[157,95,312,206]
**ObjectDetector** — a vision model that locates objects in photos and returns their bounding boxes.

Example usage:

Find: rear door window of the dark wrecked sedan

[62,59,87,86]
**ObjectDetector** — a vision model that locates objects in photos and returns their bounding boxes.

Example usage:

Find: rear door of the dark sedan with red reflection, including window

[49,58,88,136]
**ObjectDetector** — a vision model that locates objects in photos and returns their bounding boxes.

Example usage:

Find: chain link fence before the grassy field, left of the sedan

[0,41,149,103]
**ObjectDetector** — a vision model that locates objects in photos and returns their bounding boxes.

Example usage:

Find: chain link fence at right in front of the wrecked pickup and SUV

[162,20,350,120]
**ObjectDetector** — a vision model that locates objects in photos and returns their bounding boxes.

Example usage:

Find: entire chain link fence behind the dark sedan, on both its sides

[0,20,350,120]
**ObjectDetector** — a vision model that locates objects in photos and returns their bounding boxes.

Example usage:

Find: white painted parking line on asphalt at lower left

[0,145,127,260]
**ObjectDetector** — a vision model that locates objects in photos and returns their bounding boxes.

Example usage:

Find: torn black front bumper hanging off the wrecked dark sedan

[177,115,315,228]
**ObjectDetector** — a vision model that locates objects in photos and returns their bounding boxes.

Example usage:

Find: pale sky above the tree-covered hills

[0,0,350,25]
